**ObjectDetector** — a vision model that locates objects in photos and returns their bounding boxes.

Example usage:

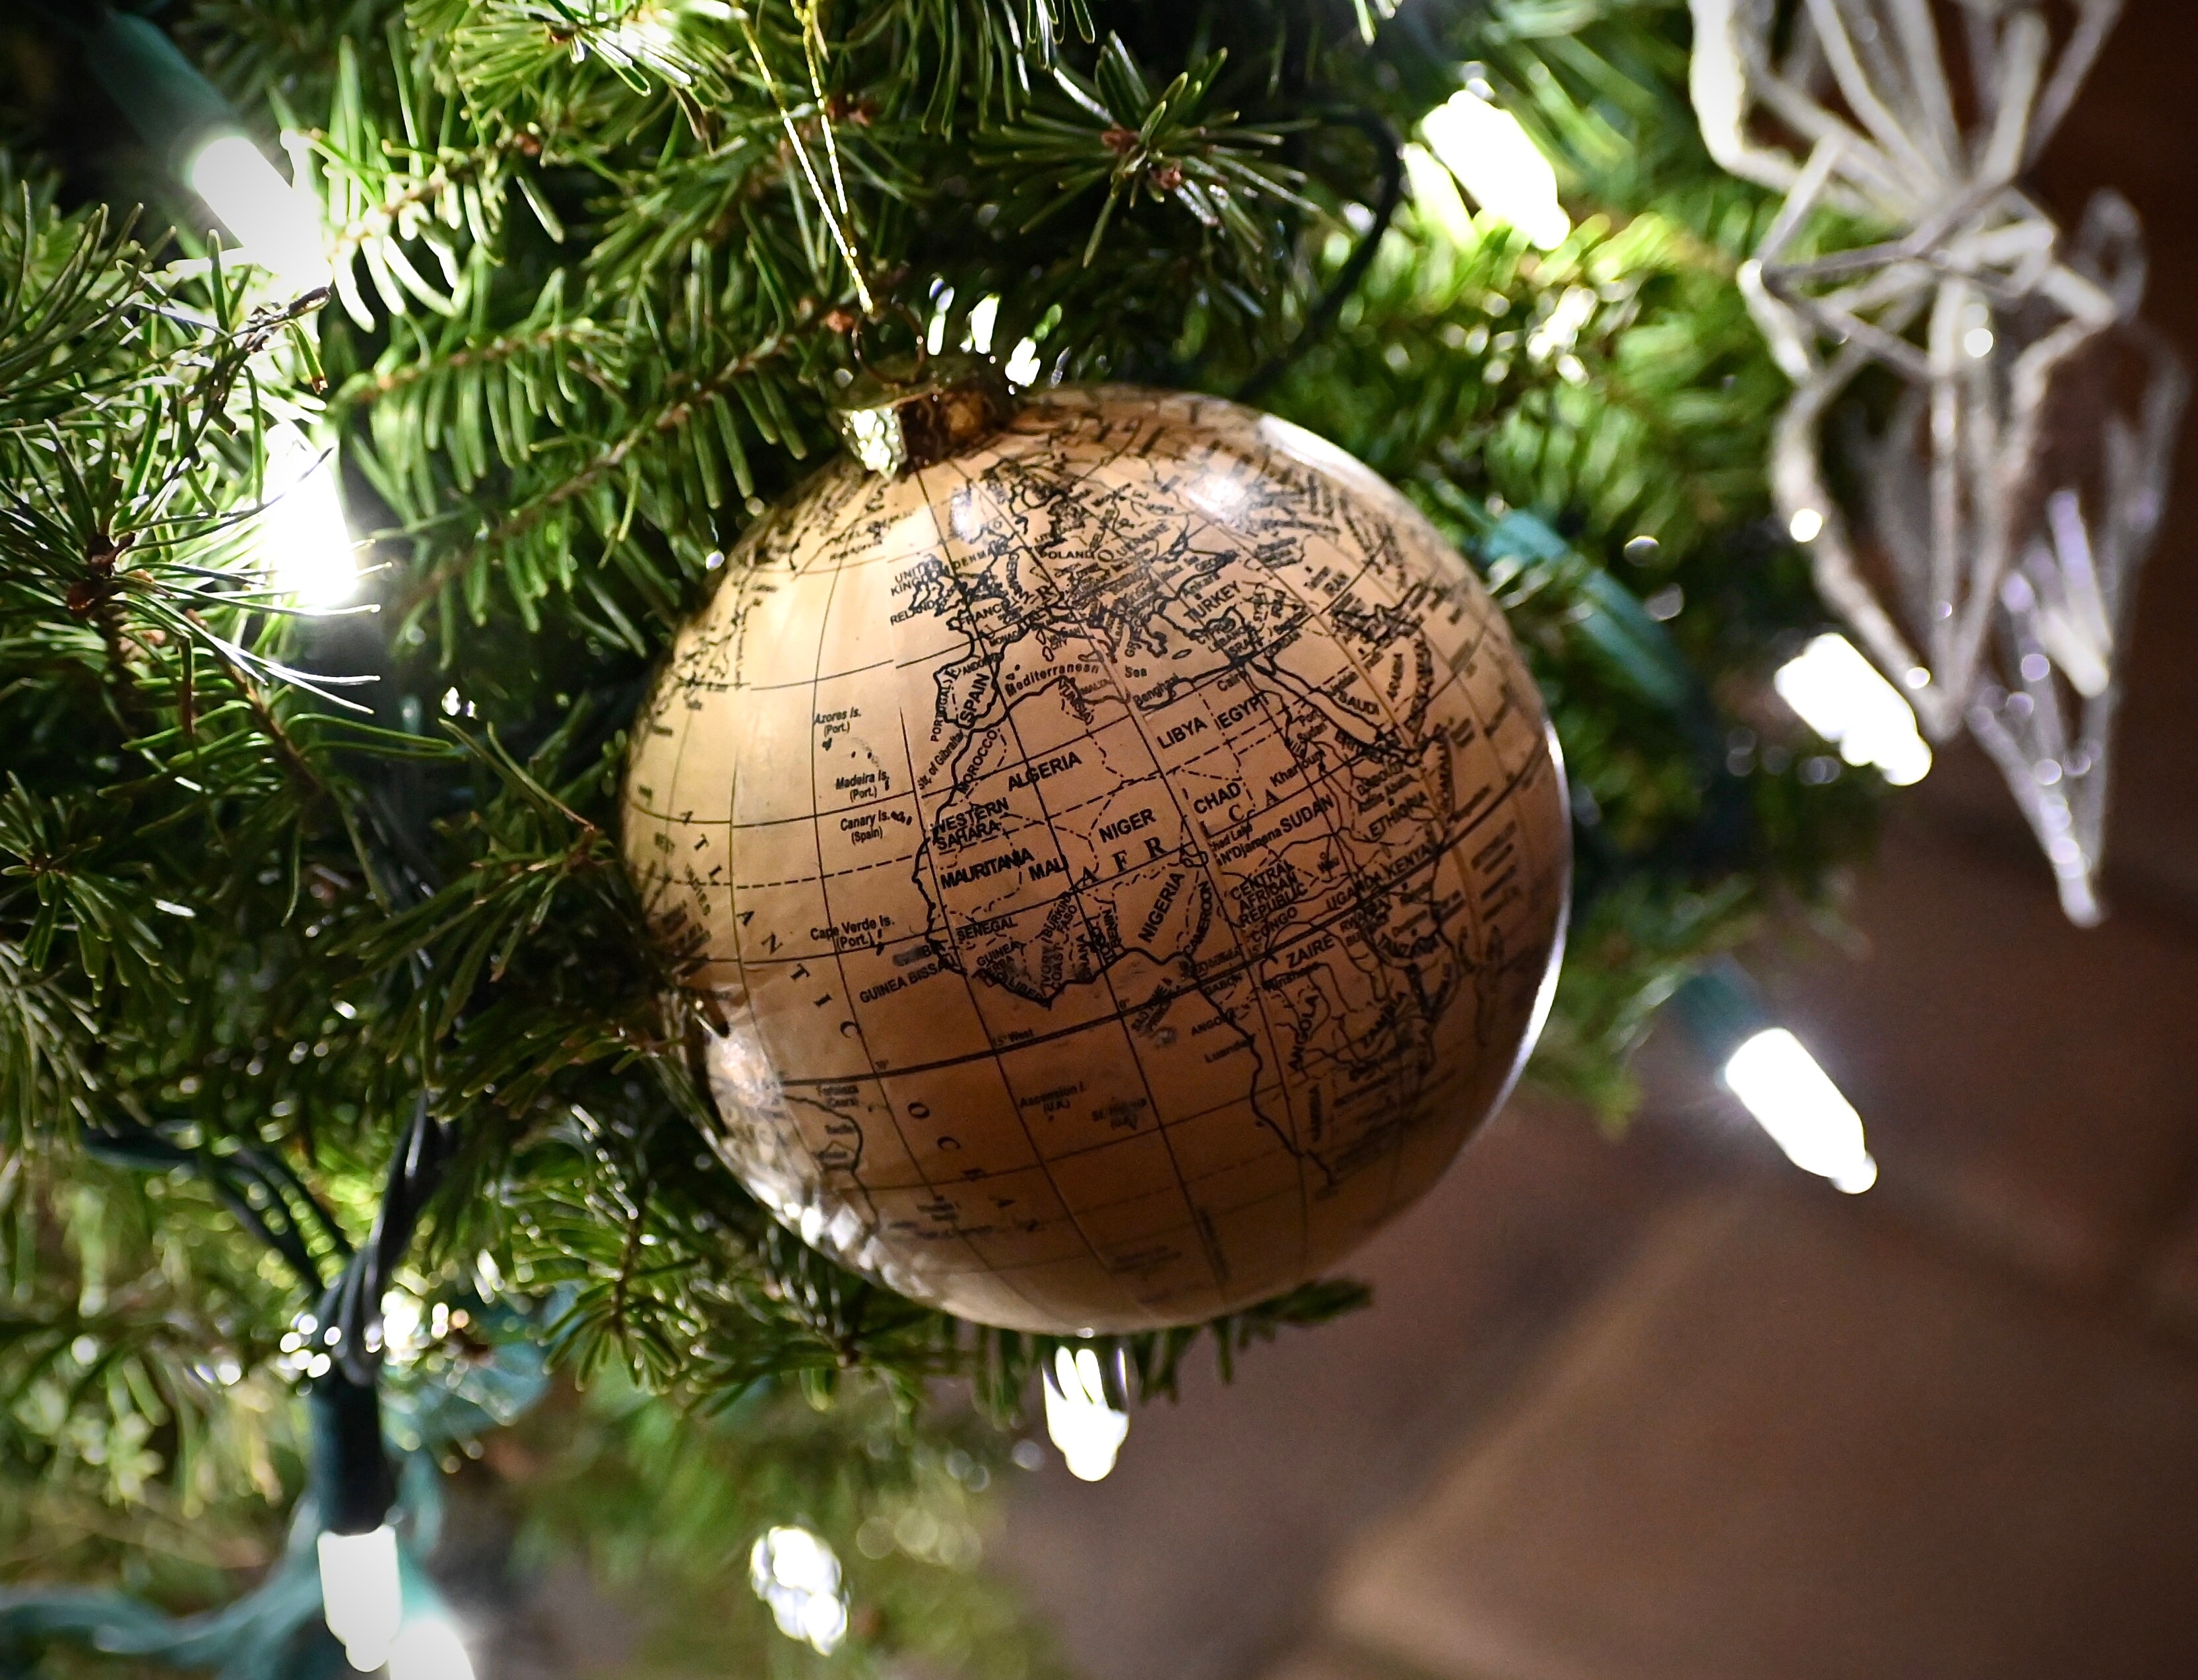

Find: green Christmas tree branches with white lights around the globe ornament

[0,0,1879,1675]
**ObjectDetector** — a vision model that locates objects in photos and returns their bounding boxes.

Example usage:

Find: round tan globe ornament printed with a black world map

[624,387,1569,1332]
